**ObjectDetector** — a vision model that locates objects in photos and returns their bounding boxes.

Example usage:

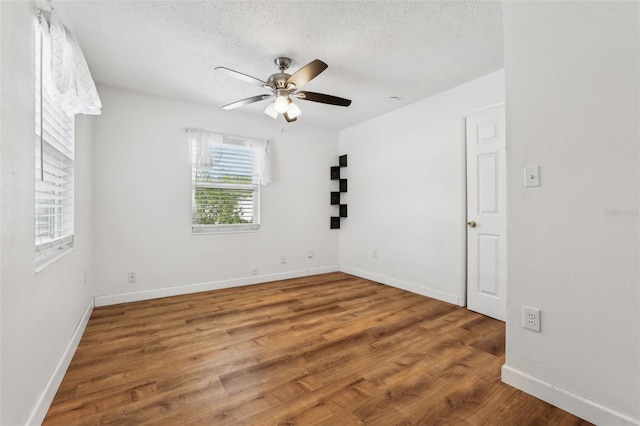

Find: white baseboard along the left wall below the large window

[27,298,94,425]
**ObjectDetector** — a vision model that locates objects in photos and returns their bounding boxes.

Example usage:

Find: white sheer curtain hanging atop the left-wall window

[40,12,102,116]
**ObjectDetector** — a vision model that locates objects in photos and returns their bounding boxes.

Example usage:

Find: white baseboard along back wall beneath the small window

[95,266,339,306]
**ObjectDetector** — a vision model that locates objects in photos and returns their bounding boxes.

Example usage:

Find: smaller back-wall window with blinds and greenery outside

[187,129,268,233]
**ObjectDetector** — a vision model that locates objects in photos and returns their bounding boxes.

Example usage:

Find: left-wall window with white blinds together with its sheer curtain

[35,9,102,271]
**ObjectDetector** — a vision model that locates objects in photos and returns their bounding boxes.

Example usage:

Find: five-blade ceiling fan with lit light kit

[215,56,351,122]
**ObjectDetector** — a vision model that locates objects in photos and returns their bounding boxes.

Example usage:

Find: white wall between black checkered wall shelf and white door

[340,71,504,305]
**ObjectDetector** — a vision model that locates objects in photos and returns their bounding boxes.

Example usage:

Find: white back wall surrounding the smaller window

[93,87,338,304]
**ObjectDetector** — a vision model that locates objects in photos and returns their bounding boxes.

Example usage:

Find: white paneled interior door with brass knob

[466,105,507,321]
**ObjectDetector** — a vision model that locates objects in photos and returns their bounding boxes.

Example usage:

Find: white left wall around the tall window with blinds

[0,2,94,425]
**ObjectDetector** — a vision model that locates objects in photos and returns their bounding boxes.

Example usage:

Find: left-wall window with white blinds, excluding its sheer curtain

[35,17,74,269]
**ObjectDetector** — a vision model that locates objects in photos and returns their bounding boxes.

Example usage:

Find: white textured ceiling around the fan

[53,0,503,129]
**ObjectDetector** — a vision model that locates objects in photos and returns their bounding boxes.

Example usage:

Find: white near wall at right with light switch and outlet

[503,2,640,425]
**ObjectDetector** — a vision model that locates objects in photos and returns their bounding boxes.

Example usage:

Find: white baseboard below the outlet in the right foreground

[502,364,640,426]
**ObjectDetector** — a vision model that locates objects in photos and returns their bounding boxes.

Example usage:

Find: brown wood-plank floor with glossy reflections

[44,273,589,425]
